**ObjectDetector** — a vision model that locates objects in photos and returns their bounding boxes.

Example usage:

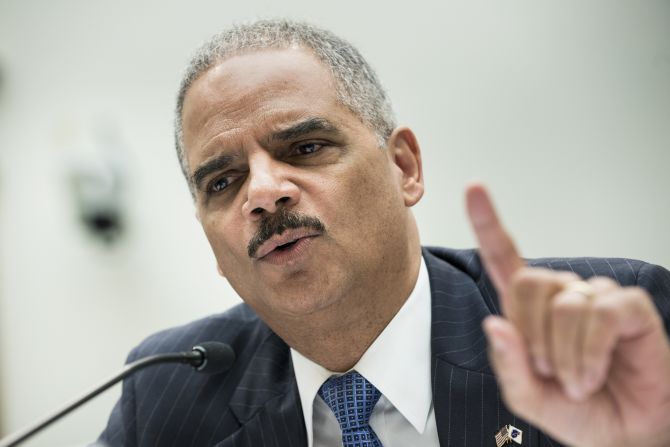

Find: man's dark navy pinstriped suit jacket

[100,248,670,447]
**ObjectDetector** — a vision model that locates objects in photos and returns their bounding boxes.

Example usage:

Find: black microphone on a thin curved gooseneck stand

[0,341,235,447]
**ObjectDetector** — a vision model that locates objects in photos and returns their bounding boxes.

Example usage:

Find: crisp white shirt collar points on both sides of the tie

[291,257,432,445]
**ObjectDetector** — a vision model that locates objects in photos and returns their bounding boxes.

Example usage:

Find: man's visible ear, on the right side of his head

[387,127,424,207]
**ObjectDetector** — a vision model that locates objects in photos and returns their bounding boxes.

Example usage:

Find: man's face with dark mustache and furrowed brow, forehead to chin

[182,49,418,321]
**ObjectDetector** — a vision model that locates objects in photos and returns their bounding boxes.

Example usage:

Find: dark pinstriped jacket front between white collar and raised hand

[424,249,538,447]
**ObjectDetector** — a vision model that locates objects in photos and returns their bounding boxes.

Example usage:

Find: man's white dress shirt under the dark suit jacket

[291,258,439,447]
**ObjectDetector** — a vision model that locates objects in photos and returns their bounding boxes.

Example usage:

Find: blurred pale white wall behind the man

[0,0,670,446]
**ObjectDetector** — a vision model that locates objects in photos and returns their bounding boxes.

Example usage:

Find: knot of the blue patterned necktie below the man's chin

[319,371,381,433]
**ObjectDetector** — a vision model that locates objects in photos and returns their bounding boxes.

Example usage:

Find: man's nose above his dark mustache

[242,153,300,220]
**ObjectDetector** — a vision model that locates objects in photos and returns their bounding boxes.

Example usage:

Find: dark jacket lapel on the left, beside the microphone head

[216,333,307,447]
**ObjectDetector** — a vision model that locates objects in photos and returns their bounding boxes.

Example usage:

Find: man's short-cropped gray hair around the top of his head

[175,20,396,192]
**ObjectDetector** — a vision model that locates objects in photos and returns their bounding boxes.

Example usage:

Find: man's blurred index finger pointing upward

[465,184,525,307]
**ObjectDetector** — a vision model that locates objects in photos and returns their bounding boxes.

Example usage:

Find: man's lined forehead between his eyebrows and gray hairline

[182,48,345,164]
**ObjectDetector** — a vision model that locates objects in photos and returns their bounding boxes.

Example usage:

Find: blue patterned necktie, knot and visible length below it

[319,371,383,447]
